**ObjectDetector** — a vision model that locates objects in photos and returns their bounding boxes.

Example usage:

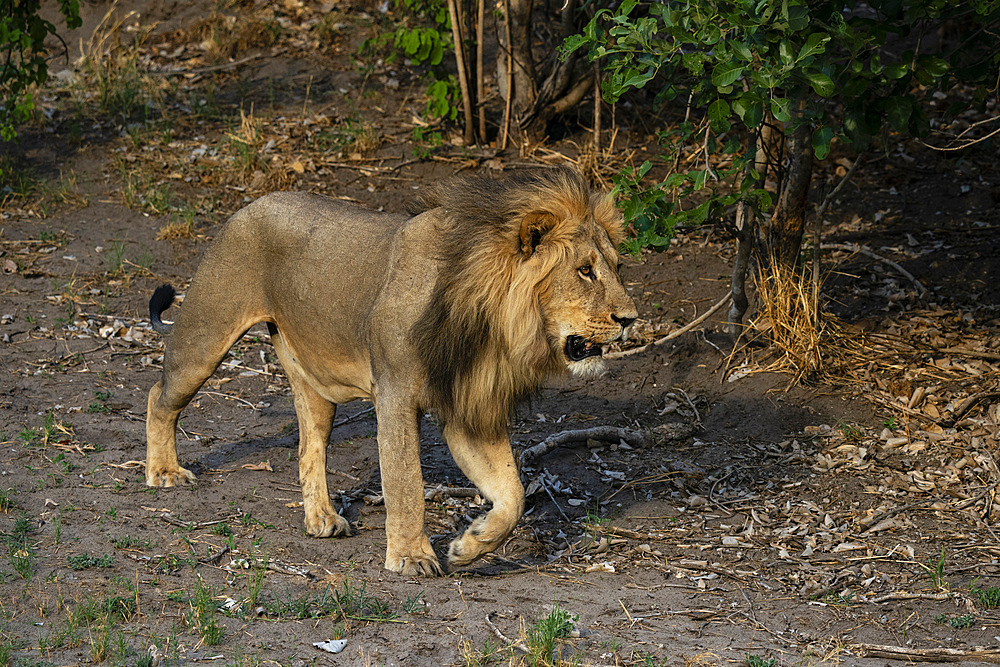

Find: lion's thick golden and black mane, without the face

[411,169,622,438]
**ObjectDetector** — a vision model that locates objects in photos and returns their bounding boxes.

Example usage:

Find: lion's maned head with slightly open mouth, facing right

[413,169,636,437]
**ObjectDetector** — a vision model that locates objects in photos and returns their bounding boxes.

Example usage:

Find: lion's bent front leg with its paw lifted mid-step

[444,425,524,567]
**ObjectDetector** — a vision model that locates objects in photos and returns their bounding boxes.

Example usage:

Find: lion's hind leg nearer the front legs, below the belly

[268,324,351,537]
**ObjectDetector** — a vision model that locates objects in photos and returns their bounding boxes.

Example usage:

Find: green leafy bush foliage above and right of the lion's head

[563,0,1000,249]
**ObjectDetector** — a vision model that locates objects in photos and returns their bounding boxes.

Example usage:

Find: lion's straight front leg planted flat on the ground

[375,397,443,576]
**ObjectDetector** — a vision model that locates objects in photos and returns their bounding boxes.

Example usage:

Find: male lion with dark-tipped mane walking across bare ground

[146,169,636,575]
